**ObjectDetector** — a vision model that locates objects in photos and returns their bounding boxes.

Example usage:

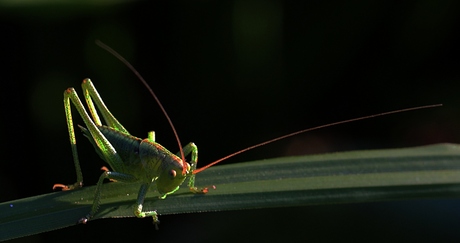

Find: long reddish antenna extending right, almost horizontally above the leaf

[193,104,442,174]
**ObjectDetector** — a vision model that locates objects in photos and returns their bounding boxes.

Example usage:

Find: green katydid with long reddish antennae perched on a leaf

[53,41,441,227]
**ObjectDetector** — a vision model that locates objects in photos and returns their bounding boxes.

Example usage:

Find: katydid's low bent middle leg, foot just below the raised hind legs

[78,170,137,224]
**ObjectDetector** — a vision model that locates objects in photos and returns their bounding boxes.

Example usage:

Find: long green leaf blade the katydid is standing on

[0,144,460,240]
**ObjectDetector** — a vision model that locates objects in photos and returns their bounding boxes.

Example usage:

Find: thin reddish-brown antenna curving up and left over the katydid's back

[96,40,187,175]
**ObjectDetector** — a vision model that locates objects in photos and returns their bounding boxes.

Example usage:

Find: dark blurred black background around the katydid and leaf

[0,0,460,242]
